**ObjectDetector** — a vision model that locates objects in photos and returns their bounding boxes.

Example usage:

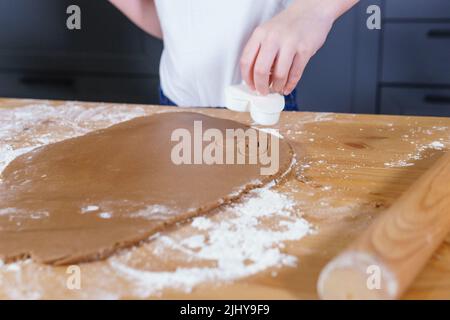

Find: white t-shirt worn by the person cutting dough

[155,0,290,107]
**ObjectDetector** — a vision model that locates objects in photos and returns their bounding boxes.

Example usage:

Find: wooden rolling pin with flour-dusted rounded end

[317,152,450,299]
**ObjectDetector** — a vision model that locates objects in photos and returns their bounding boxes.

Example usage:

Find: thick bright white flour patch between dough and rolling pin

[109,188,315,297]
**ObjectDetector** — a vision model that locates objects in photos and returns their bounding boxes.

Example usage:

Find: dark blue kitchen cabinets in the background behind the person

[0,0,450,116]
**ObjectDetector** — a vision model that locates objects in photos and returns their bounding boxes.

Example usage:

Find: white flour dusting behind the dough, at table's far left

[0,102,145,174]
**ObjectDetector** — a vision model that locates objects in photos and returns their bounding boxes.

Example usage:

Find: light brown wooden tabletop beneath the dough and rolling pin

[0,99,450,299]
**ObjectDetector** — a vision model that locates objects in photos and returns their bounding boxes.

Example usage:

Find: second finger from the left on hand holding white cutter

[253,42,278,95]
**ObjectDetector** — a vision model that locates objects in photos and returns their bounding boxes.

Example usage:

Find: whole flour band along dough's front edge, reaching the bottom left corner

[0,188,315,299]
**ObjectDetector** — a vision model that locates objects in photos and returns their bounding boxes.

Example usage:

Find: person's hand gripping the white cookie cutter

[241,0,356,95]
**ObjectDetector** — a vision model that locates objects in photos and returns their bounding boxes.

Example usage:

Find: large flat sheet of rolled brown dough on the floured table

[0,112,293,265]
